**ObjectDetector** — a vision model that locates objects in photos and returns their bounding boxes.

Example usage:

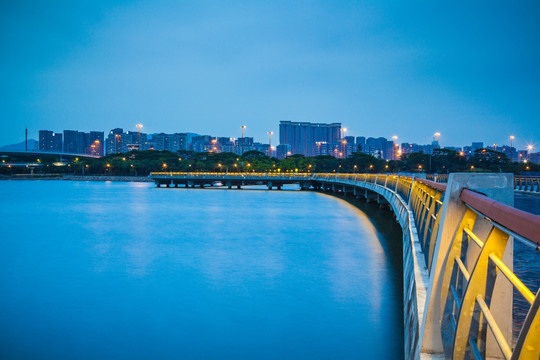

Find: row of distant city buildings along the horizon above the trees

[6,121,540,163]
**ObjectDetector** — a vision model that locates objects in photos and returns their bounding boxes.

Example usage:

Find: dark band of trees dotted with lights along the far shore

[0,149,540,176]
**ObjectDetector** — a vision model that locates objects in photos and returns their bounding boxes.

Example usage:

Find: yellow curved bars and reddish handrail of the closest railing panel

[441,189,540,359]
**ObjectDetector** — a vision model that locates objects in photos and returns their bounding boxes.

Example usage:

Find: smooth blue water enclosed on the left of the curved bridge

[0,181,403,359]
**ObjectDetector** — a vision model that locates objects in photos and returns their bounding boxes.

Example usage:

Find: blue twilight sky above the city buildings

[0,0,540,151]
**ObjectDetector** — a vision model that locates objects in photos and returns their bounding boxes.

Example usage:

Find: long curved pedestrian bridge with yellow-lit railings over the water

[151,172,540,360]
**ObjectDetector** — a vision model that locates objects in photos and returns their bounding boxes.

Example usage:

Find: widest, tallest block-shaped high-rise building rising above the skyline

[279,121,341,156]
